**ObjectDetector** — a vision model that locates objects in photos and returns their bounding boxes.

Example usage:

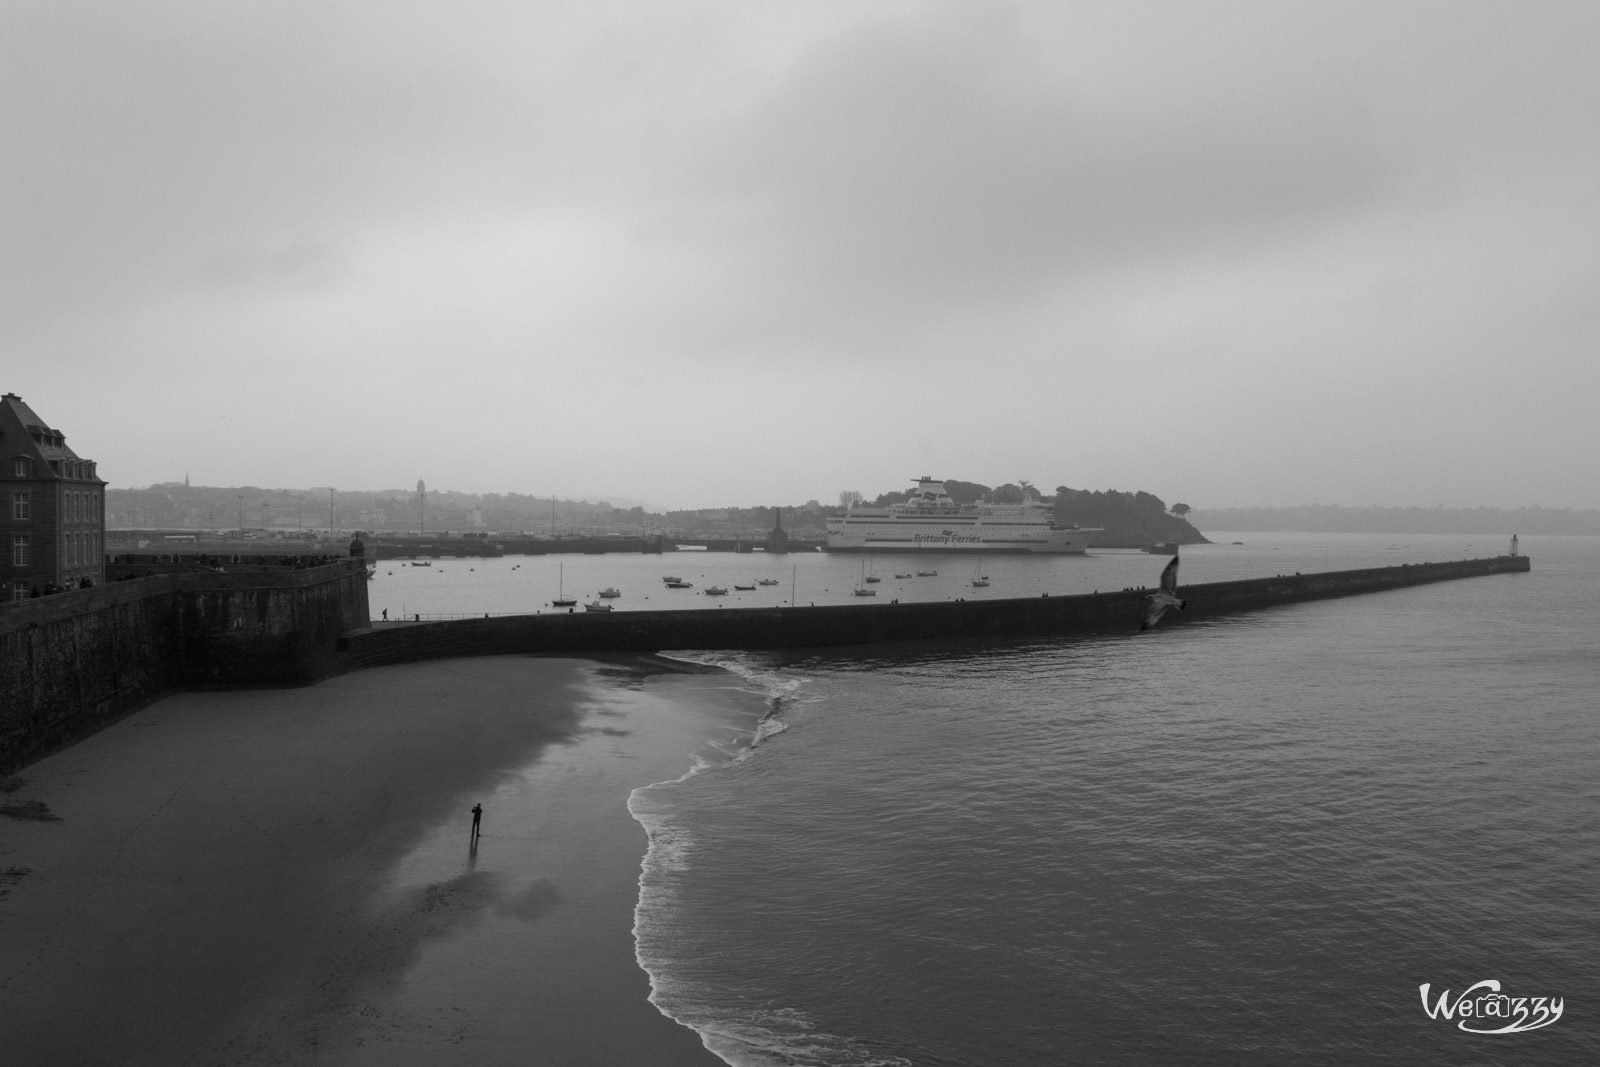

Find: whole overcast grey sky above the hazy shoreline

[0,0,1600,509]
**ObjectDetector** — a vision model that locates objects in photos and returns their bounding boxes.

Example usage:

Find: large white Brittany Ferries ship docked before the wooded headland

[827,477,1101,555]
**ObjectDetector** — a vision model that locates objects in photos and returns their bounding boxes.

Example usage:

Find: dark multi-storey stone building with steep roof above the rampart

[0,394,106,600]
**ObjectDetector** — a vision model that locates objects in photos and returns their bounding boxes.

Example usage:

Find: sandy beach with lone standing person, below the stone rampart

[0,657,748,1067]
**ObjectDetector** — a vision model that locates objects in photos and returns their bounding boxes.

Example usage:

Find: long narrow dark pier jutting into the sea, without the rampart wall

[339,555,1531,670]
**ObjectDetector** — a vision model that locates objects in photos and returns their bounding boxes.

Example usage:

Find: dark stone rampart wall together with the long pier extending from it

[0,555,1530,774]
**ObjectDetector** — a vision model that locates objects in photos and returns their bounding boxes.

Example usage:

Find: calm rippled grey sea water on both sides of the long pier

[384,534,1600,1067]
